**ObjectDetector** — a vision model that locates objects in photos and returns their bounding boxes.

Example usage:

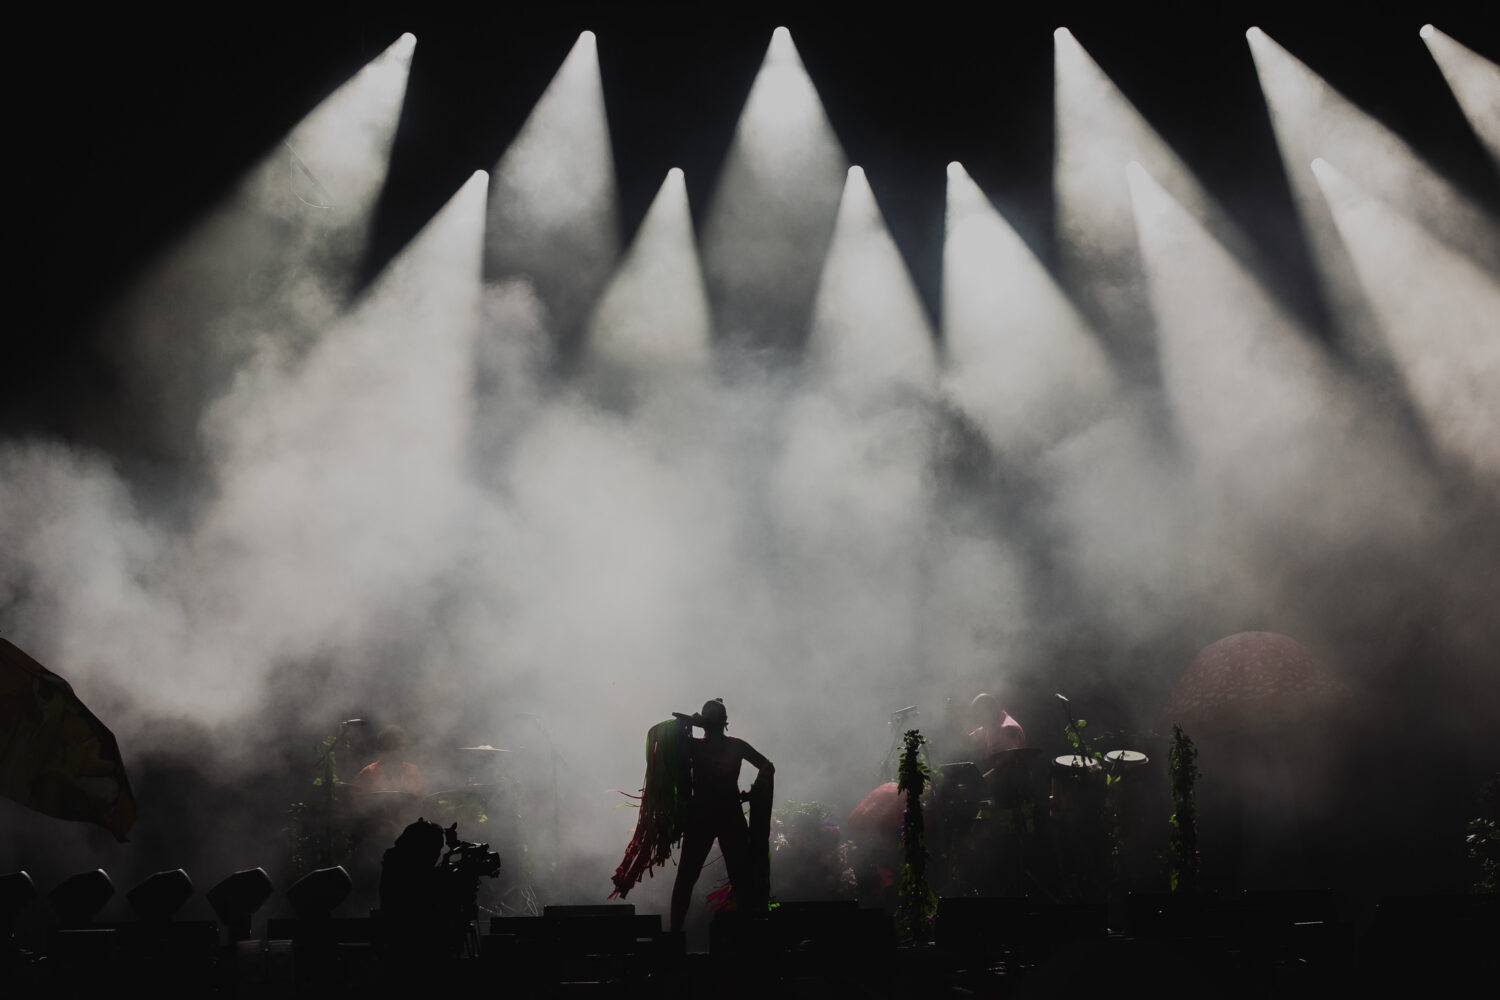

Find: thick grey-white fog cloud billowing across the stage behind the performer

[0,27,1500,903]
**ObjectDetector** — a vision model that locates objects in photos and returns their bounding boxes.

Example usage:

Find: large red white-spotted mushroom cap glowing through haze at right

[1163,633,1349,732]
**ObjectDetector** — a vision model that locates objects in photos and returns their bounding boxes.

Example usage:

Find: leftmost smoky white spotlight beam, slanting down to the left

[104,34,417,460]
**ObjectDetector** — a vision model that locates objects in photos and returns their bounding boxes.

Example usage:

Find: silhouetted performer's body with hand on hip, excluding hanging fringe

[672,699,776,931]
